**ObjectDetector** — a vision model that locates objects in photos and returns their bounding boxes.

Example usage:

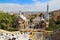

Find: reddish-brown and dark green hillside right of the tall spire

[47,10,60,30]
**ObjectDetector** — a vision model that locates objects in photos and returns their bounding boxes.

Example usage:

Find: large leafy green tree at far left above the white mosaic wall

[0,13,16,30]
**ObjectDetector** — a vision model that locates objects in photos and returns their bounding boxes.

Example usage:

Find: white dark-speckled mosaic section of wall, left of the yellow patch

[0,32,30,40]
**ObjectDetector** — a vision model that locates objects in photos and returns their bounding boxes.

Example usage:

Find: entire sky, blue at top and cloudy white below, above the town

[0,0,60,12]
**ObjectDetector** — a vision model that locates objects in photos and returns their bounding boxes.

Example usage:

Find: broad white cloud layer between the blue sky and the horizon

[0,0,60,12]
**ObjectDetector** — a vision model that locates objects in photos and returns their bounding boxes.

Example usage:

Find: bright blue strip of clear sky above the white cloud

[0,0,49,4]
